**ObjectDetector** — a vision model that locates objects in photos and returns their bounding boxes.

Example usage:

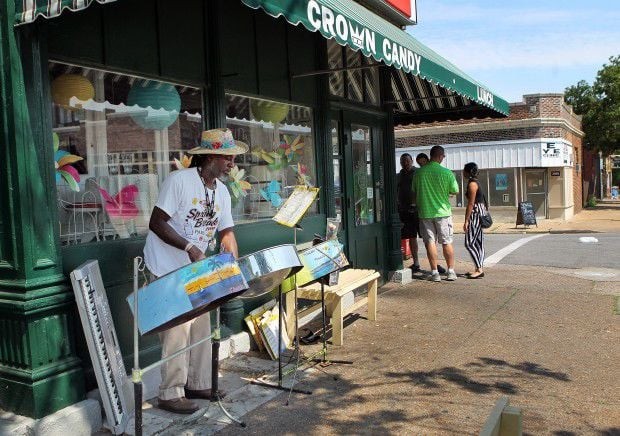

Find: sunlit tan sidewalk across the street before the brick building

[453,201,620,233]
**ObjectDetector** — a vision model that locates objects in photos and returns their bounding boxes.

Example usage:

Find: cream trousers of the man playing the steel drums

[159,313,211,400]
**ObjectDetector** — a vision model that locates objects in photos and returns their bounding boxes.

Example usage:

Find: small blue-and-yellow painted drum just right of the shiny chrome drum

[295,239,349,286]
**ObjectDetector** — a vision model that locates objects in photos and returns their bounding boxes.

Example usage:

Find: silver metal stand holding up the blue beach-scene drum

[131,256,246,436]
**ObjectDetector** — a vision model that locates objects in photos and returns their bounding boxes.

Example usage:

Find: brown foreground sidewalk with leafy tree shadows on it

[217,265,620,436]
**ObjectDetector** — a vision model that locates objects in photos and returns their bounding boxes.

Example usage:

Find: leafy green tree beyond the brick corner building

[564,55,620,155]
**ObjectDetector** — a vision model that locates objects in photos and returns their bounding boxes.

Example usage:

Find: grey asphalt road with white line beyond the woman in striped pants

[450,233,620,269]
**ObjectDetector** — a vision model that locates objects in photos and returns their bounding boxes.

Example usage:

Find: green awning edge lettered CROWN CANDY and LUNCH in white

[241,0,509,115]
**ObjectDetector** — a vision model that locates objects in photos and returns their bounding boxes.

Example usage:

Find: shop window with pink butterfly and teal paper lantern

[49,63,202,244]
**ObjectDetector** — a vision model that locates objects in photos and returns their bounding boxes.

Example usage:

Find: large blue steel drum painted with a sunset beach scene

[127,253,248,335]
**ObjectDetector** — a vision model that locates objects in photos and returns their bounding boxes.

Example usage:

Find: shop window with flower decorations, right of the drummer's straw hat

[226,94,318,223]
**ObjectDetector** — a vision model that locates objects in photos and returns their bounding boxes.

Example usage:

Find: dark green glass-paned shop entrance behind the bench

[331,111,385,271]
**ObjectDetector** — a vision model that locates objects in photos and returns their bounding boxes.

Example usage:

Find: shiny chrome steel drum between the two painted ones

[237,244,303,298]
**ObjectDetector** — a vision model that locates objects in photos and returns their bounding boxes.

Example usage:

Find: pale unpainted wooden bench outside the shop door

[286,269,381,345]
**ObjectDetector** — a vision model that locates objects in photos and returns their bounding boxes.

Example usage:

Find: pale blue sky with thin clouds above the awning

[407,0,620,103]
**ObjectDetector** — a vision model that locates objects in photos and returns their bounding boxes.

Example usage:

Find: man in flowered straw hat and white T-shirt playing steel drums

[144,129,248,414]
